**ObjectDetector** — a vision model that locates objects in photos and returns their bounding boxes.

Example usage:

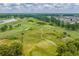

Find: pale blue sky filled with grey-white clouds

[0,3,79,13]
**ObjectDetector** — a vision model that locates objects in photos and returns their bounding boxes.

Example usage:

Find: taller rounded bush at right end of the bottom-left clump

[9,42,22,56]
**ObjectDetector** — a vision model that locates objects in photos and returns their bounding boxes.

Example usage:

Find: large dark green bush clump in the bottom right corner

[57,40,79,56]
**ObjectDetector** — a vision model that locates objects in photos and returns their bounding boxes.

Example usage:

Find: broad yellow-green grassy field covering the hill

[0,17,79,56]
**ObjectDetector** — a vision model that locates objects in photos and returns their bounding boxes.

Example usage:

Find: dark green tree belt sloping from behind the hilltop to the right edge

[29,15,79,30]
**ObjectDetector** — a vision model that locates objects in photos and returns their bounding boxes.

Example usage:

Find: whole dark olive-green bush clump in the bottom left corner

[0,41,22,56]
